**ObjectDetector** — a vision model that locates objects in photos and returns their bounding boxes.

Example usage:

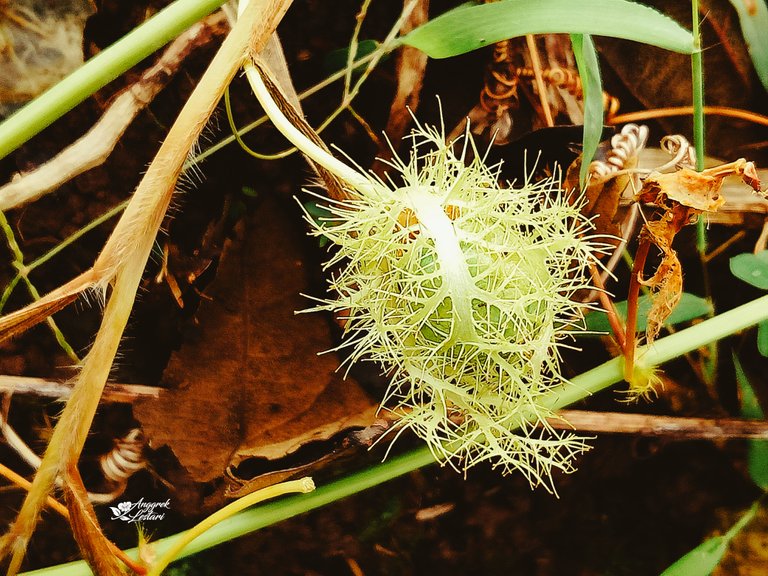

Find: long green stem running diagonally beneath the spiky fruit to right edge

[22,296,768,576]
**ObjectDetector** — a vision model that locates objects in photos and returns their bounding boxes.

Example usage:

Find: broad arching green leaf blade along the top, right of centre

[401,0,694,58]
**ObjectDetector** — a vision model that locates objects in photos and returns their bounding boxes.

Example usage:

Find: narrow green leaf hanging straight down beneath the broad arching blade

[571,34,603,189]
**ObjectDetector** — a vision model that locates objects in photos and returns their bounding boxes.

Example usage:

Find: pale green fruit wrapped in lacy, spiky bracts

[309,126,600,486]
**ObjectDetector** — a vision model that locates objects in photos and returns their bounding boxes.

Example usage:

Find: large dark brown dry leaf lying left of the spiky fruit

[134,196,375,490]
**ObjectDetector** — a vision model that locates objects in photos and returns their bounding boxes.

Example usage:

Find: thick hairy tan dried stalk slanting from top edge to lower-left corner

[0,0,290,574]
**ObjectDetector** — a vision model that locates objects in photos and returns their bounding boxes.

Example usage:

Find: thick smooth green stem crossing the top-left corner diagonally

[0,0,225,158]
